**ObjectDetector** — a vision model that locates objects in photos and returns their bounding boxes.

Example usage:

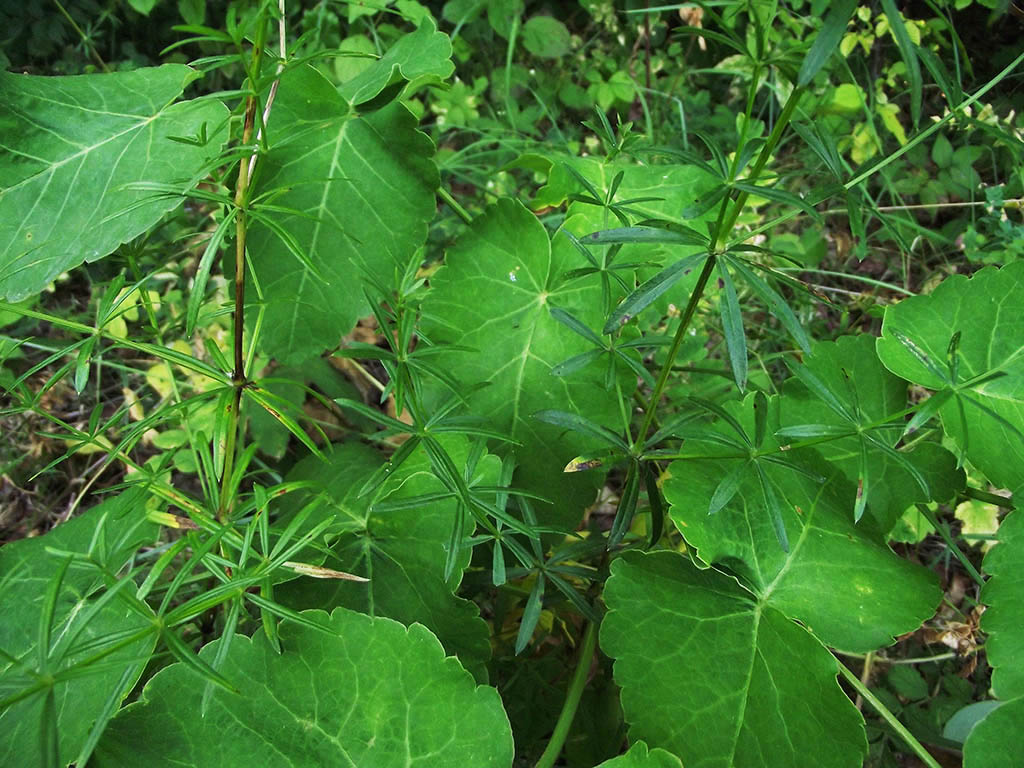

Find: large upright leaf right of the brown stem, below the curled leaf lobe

[249,66,438,364]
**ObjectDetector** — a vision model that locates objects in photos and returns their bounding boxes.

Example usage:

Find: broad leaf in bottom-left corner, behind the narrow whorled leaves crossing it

[0,490,157,766]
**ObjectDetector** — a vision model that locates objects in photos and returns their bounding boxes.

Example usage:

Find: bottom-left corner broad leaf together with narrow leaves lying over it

[0,490,157,765]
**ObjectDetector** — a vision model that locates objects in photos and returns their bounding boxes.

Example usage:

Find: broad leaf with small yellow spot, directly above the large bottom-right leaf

[663,396,942,651]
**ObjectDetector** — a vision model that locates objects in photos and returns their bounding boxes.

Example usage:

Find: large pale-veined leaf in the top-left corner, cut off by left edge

[0,65,227,301]
